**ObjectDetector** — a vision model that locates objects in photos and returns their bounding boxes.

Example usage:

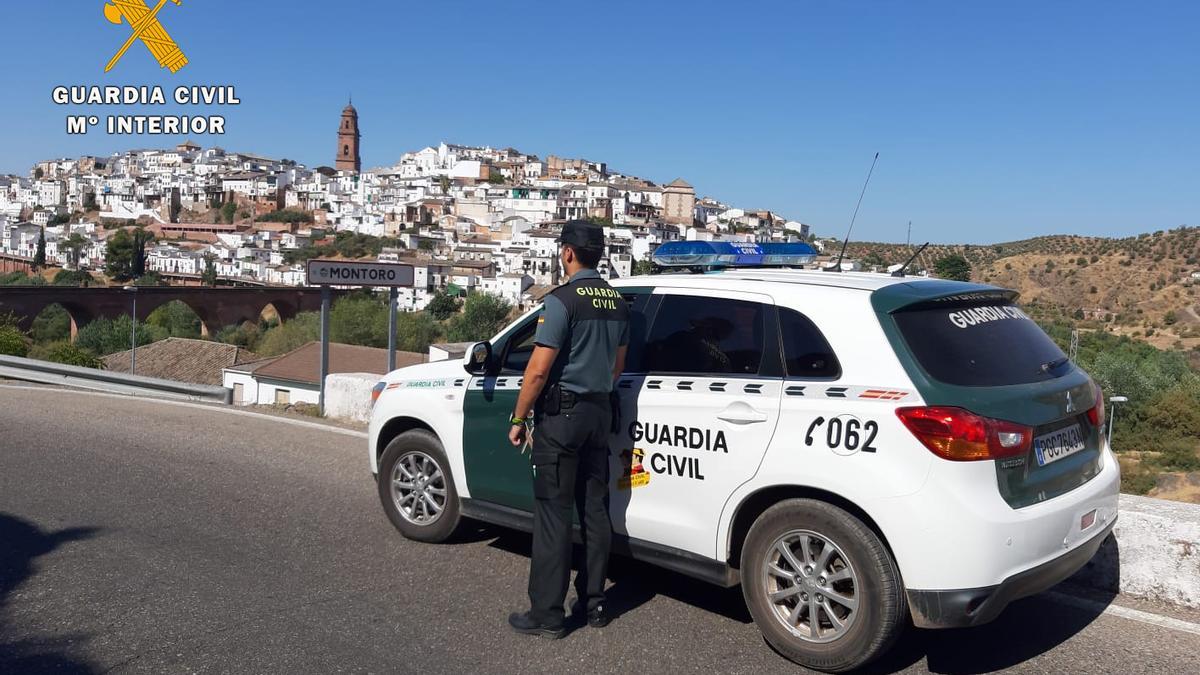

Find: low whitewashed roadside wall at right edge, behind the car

[1073,495,1200,608]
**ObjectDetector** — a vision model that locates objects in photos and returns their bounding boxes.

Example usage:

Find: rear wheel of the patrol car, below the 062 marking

[742,500,907,673]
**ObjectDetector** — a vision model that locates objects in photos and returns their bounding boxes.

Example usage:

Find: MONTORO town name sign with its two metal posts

[308,259,416,416]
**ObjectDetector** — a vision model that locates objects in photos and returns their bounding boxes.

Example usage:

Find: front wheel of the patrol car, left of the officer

[378,429,462,543]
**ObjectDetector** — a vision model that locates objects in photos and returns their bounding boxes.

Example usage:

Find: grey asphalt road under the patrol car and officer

[0,386,1200,674]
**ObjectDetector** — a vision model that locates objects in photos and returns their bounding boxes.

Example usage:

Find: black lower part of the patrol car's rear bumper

[907,518,1116,628]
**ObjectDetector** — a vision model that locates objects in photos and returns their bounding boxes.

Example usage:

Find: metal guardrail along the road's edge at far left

[0,356,233,405]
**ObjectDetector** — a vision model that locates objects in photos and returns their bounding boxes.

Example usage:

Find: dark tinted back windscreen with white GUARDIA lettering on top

[893,300,1067,387]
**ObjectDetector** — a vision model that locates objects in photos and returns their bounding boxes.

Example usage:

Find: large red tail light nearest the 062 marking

[896,406,1033,461]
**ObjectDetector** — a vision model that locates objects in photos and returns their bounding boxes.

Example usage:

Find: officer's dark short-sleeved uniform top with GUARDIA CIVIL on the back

[534,269,629,394]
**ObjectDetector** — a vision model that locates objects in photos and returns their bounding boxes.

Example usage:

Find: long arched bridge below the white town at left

[0,286,340,336]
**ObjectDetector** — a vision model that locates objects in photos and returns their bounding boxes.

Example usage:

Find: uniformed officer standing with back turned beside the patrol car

[509,220,629,638]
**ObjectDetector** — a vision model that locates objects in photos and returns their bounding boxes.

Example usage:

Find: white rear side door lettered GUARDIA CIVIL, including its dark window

[611,288,784,556]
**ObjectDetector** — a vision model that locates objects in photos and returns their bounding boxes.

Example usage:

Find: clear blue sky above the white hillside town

[0,0,1200,243]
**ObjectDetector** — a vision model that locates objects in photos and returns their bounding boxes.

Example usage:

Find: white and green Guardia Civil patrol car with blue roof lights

[370,241,1120,671]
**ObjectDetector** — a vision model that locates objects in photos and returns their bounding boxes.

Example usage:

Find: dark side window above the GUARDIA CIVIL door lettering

[643,295,766,375]
